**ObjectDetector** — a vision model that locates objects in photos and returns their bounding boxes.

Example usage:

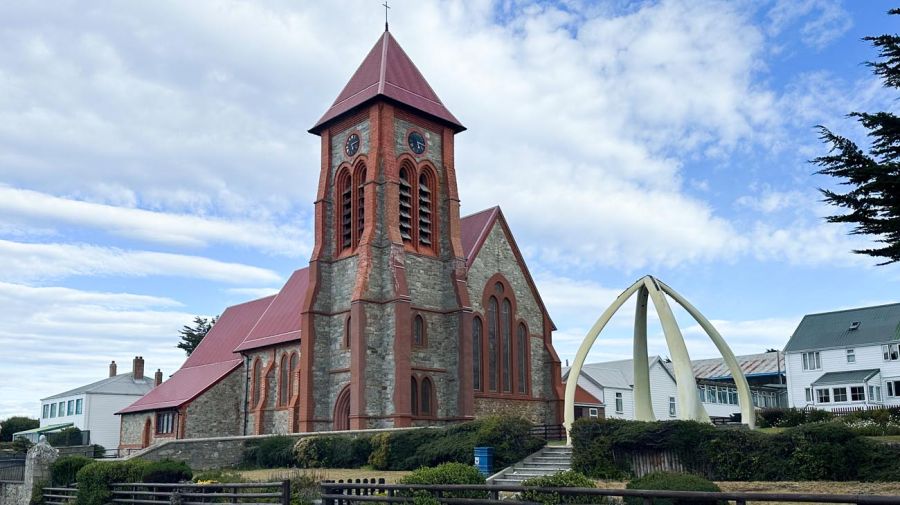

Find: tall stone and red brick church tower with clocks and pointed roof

[299,30,473,431]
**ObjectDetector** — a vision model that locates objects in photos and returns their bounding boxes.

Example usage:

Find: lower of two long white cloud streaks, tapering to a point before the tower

[0,240,282,284]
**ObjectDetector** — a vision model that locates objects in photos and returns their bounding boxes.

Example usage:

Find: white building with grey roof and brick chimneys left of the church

[41,356,162,449]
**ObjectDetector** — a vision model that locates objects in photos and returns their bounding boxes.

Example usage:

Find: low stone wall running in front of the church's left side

[126,428,419,470]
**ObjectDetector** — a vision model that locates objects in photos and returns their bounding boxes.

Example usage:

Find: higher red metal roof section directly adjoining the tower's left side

[234,268,309,351]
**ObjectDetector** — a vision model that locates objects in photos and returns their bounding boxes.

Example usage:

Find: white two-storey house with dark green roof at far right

[784,303,900,410]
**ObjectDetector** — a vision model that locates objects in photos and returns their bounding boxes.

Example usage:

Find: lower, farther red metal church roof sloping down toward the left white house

[117,295,275,414]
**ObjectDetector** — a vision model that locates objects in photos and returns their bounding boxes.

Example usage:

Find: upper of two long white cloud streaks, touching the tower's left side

[0,186,310,257]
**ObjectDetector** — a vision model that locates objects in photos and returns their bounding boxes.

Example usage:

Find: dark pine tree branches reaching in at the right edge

[812,9,900,265]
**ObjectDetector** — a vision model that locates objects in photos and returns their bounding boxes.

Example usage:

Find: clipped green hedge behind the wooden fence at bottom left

[75,459,193,505]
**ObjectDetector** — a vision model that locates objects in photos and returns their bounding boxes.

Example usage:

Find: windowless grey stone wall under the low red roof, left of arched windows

[184,366,246,438]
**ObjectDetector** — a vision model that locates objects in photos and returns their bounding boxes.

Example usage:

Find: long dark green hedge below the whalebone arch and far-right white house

[572,419,900,481]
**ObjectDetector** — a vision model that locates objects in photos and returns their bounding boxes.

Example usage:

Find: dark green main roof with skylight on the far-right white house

[784,303,900,352]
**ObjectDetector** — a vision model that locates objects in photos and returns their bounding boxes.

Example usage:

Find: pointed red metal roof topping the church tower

[309,31,466,134]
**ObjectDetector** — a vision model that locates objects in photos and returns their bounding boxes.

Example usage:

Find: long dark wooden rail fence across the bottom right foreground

[322,483,900,505]
